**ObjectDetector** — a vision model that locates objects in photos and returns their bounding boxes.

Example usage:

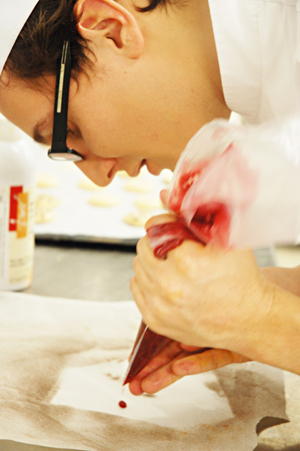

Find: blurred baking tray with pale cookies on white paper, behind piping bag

[33,146,172,246]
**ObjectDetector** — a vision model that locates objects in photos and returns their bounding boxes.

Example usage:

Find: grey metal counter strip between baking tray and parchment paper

[24,241,135,304]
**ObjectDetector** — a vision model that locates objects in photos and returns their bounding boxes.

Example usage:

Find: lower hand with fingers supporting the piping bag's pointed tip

[129,341,249,395]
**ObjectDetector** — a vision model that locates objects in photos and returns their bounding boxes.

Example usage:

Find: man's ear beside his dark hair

[74,0,144,58]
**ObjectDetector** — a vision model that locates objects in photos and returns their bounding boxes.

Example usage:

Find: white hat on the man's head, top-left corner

[0,0,38,74]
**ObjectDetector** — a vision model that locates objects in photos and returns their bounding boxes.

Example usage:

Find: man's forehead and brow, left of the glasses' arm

[0,74,55,135]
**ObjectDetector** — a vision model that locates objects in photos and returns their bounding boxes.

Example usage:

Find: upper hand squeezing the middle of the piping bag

[131,215,272,358]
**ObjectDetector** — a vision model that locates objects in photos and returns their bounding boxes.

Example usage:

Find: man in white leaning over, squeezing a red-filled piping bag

[0,0,300,395]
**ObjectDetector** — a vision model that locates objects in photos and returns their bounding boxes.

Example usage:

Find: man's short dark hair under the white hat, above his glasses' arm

[5,0,169,80]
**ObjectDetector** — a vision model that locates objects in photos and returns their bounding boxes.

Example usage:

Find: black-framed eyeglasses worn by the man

[48,41,84,161]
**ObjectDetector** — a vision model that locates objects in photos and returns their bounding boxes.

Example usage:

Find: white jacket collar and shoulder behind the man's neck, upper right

[209,0,300,124]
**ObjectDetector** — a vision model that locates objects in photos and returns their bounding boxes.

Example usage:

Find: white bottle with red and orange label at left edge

[0,117,36,291]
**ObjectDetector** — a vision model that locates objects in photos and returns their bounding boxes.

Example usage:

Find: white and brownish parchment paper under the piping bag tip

[0,292,286,451]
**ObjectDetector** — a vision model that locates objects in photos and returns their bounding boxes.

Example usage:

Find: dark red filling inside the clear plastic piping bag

[123,168,230,385]
